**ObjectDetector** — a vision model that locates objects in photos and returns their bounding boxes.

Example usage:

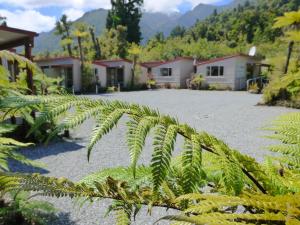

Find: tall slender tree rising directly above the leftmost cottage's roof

[55,14,73,56]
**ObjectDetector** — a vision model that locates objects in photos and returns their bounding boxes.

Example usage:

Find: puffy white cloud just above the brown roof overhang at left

[0,9,56,32]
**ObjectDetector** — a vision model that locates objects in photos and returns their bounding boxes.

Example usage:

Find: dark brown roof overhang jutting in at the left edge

[0,26,38,50]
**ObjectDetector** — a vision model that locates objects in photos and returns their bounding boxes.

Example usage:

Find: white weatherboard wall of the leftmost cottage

[36,58,82,92]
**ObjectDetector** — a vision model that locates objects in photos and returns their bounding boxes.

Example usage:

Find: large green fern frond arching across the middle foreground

[1,96,268,193]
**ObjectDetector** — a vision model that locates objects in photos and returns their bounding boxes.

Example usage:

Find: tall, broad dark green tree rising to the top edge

[106,0,144,44]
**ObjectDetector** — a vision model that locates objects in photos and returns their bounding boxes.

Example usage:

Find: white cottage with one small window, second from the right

[141,57,194,88]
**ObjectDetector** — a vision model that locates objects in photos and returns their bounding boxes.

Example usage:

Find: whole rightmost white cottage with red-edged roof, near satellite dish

[197,54,263,90]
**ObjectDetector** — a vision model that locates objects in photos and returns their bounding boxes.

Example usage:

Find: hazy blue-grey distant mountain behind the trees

[33,0,246,53]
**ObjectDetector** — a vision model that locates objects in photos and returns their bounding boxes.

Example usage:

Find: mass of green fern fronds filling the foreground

[0,92,300,224]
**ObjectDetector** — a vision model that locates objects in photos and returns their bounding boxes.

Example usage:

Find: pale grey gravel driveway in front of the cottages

[11,90,296,225]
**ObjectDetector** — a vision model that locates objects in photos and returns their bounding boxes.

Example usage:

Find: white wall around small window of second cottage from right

[151,59,193,88]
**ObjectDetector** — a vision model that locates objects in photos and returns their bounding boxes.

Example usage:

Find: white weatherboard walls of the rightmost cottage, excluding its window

[197,56,260,90]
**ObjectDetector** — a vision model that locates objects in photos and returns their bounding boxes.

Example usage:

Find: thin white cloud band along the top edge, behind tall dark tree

[0,0,220,12]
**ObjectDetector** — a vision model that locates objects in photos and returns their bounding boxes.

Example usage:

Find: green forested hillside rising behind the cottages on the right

[143,0,300,60]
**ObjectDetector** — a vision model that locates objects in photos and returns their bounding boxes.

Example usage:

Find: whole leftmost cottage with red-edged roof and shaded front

[35,57,82,92]
